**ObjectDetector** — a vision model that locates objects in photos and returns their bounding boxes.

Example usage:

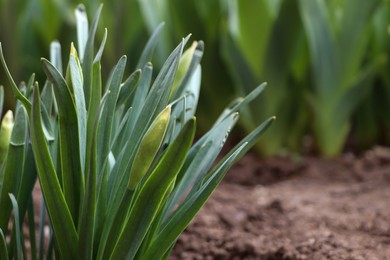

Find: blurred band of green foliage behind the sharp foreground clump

[0,0,390,156]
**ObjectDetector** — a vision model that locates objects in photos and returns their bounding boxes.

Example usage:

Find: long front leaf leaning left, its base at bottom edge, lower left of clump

[29,86,78,259]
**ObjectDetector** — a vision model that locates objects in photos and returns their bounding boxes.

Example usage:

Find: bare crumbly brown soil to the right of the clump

[169,147,390,260]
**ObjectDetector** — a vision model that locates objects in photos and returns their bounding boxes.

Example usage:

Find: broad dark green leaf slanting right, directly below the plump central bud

[110,119,195,259]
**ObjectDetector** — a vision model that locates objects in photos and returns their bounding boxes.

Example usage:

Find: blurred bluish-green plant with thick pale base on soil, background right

[299,0,381,156]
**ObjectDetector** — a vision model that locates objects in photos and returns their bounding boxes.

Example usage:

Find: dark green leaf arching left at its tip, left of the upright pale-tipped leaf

[42,59,84,222]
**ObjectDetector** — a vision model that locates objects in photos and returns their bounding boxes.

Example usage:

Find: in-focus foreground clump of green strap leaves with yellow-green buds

[0,5,274,259]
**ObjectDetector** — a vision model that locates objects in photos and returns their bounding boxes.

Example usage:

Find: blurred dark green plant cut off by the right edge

[353,1,390,149]
